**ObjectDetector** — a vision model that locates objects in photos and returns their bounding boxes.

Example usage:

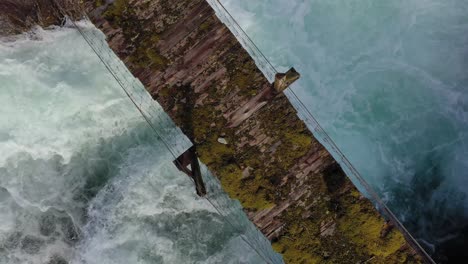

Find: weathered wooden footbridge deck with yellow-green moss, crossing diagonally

[0,0,422,263]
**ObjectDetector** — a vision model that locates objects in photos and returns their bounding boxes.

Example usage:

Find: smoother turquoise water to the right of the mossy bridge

[221,0,468,261]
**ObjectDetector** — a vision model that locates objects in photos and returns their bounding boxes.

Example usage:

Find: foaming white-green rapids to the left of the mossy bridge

[0,25,278,264]
